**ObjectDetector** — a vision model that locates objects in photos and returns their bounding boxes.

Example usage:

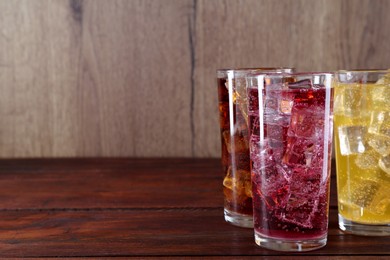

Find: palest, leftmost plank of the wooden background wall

[0,0,81,157]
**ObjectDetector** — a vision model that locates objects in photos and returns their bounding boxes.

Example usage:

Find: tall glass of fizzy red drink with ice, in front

[248,73,333,251]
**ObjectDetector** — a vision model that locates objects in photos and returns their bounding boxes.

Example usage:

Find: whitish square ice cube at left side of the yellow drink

[338,126,367,155]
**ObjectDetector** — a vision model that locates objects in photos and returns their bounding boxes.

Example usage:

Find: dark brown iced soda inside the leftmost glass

[218,78,253,215]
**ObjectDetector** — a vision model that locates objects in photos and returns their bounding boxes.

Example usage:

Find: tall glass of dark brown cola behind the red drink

[217,68,292,228]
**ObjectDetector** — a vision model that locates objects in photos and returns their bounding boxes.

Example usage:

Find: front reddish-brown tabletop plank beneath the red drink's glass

[0,209,390,257]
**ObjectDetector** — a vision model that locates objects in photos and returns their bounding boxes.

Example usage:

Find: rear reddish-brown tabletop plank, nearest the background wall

[0,158,337,212]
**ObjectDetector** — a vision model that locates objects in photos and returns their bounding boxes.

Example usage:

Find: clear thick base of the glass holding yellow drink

[339,214,390,236]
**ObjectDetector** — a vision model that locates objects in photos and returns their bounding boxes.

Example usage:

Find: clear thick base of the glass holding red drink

[255,232,327,252]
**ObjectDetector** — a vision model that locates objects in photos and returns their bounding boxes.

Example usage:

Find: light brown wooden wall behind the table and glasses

[0,0,390,158]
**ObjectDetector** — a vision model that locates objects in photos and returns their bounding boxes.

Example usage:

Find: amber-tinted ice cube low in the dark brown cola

[223,167,252,197]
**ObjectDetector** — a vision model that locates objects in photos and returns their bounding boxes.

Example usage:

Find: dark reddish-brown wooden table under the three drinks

[0,159,390,259]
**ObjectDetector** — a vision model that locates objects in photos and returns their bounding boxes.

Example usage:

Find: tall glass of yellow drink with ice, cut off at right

[334,70,390,236]
